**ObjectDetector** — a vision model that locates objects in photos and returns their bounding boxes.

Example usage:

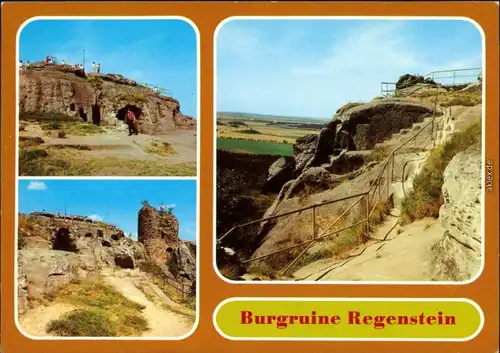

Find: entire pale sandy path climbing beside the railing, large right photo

[293,107,466,281]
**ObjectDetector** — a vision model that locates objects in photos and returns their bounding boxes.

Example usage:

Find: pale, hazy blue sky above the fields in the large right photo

[216,19,482,118]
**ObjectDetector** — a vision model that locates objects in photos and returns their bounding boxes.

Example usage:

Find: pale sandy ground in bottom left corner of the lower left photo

[19,303,76,337]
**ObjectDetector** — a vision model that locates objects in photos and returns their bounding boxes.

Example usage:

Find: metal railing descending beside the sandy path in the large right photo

[217,90,451,275]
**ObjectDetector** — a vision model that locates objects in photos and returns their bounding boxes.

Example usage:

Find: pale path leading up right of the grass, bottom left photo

[104,271,193,337]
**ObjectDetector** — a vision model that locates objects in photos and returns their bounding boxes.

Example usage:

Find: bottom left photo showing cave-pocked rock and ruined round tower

[16,179,198,339]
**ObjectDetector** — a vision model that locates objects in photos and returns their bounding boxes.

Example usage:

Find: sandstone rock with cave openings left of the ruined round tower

[18,213,145,312]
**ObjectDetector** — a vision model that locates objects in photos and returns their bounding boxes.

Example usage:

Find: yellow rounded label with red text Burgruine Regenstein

[214,298,484,341]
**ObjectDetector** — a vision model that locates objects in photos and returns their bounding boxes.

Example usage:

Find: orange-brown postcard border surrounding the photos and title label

[1,1,499,353]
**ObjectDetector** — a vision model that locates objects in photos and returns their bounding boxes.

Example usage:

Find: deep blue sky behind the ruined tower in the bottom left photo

[18,179,197,240]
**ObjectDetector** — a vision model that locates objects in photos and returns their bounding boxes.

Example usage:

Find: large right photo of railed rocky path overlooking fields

[214,17,485,284]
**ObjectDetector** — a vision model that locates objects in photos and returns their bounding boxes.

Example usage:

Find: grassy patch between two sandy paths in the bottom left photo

[46,280,149,337]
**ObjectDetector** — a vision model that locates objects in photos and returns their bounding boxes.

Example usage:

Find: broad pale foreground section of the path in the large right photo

[294,219,444,281]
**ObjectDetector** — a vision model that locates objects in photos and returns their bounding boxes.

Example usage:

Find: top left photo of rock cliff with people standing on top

[17,17,199,177]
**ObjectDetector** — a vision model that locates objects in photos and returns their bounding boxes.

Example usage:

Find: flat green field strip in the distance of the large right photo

[217,138,293,156]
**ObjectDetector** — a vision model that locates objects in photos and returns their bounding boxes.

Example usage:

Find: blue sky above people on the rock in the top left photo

[19,19,197,118]
